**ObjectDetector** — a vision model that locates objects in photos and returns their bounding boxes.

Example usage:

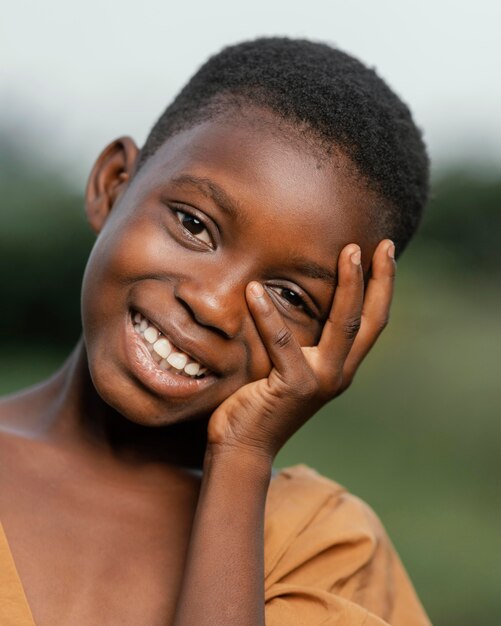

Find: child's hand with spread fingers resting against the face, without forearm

[208,239,395,460]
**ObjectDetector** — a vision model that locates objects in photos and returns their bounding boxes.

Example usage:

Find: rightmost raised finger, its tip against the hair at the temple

[343,239,396,384]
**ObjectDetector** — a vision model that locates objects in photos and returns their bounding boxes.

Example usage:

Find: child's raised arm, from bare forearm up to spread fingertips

[174,241,394,626]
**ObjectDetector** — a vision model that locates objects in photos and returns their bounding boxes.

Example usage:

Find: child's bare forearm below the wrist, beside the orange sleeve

[174,449,271,626]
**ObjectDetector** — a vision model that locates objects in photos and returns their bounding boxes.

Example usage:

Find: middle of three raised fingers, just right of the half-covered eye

[318,244,364,372]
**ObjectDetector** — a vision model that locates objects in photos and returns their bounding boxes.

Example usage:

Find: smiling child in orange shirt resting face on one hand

[0,38,429,626]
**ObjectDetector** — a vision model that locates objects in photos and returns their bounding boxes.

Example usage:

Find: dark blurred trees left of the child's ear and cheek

[0,132,94,346]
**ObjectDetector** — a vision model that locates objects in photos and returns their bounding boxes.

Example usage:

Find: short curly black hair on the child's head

[138,37,429,256]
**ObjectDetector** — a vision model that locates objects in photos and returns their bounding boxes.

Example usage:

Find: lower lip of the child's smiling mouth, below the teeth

[125,312,216,398]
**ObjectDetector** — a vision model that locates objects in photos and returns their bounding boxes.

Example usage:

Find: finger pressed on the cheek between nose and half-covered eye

[246,282,306,375]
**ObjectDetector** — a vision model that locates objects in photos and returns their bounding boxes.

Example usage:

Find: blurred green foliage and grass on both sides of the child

[0,132,501,626]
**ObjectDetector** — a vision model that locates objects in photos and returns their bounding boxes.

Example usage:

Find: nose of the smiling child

[175,277,247,339]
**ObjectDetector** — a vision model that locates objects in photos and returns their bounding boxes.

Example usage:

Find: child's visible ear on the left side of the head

[85,137,139,233]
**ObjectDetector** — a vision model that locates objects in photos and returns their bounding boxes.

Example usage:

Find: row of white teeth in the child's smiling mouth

[133,312,208,379]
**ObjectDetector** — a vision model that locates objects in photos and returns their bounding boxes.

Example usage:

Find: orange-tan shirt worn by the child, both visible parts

[0,465,430,626]
